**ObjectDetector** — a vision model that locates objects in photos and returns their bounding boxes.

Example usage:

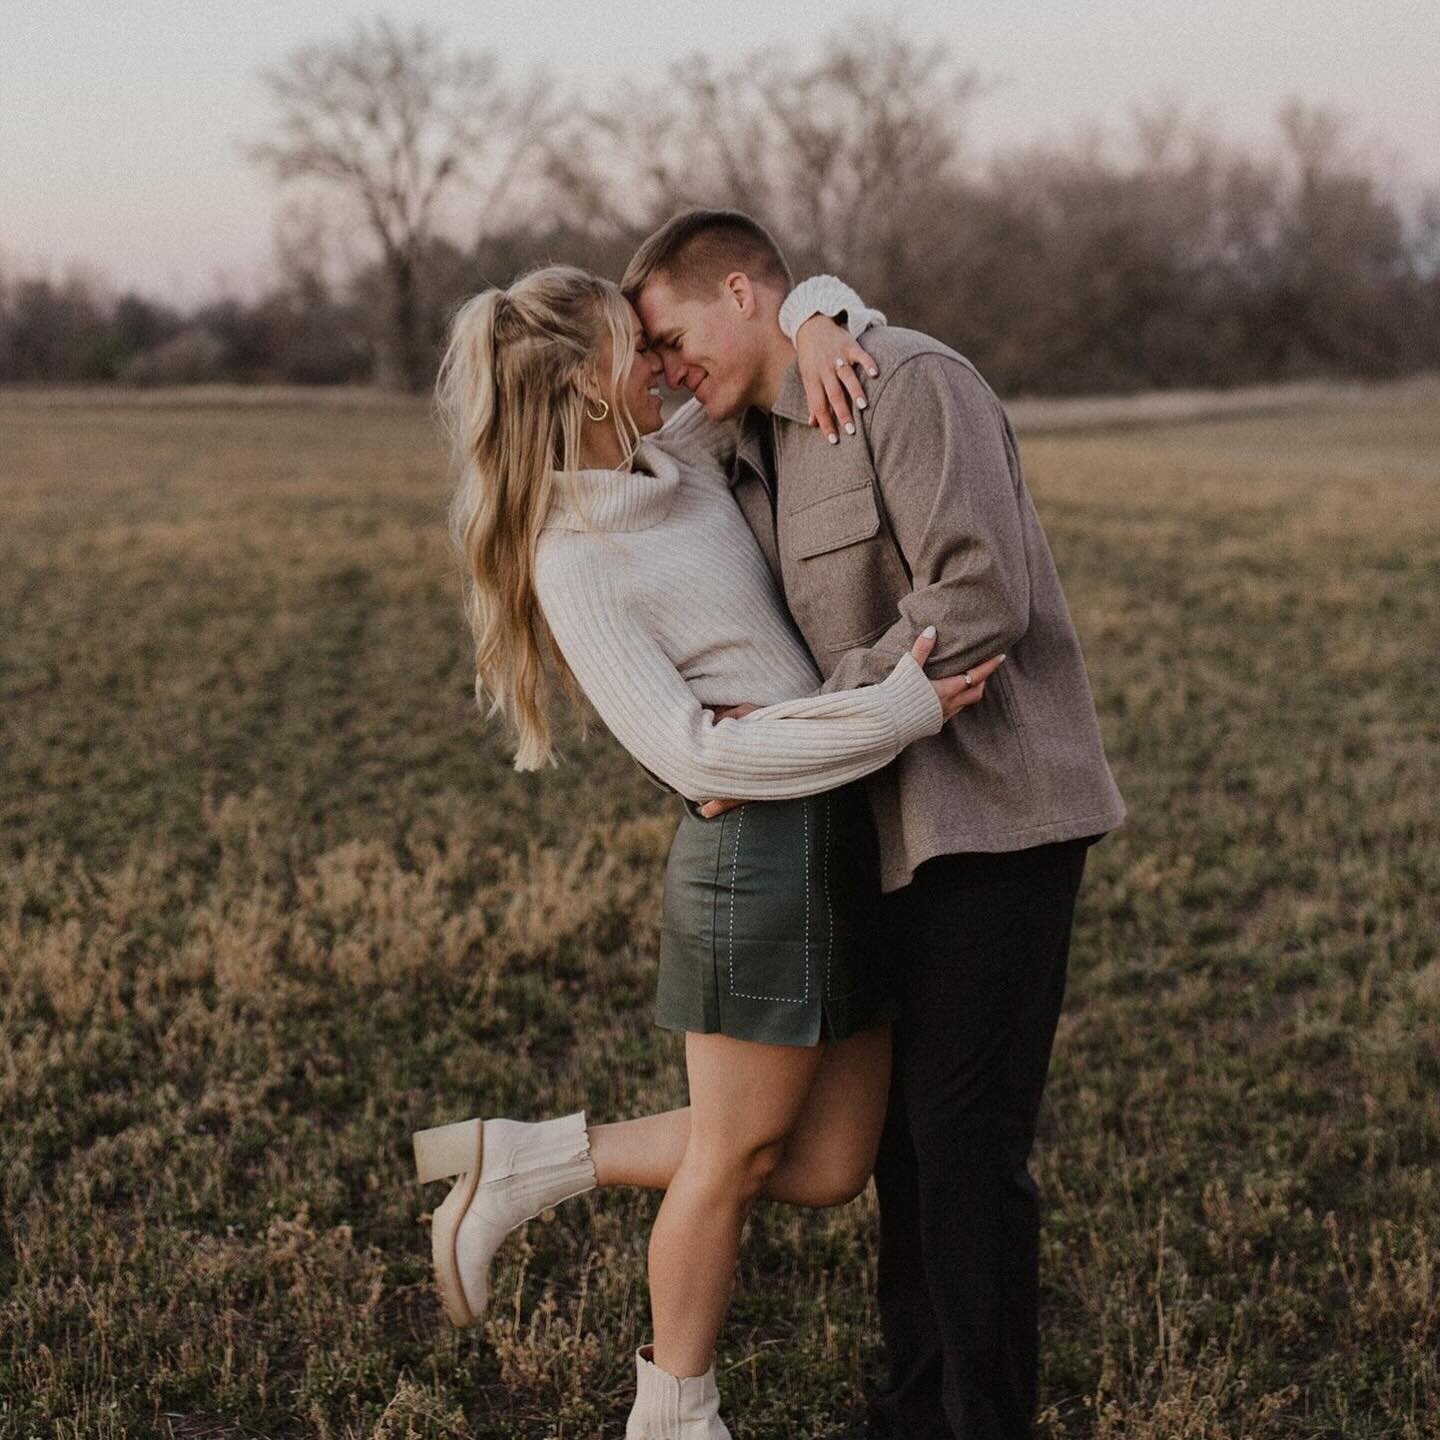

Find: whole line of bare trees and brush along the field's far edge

[0,19,1440,393]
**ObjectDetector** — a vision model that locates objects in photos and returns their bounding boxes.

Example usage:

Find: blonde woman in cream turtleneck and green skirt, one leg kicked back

[415,266,1004,1440]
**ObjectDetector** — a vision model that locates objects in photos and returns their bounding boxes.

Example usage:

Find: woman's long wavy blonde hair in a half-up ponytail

[435,265,639,770]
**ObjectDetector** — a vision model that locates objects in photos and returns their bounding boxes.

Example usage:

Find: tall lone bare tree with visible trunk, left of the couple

[249,19,547,389]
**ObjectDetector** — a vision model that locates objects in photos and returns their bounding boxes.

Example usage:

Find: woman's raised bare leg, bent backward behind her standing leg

[590,1025,890,1207]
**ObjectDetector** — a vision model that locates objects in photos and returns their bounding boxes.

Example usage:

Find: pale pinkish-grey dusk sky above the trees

[0,0,1440,304]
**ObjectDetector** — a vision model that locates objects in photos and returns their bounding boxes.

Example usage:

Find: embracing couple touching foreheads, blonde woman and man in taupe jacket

[415,210,1125,1440]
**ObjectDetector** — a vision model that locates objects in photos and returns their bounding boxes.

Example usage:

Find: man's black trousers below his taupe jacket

[873,837,1094,1440]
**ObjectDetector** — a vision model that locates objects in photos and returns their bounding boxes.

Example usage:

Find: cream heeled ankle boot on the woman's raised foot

[412,1110,595,1325]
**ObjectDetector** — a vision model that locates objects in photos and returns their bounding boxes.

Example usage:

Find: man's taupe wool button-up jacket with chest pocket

[732,327,1125,890]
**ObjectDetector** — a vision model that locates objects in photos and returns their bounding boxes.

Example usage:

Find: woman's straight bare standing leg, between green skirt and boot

[649,1032,822,1377]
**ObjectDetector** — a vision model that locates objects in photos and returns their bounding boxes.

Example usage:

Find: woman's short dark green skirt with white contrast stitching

[655,782,897,1045]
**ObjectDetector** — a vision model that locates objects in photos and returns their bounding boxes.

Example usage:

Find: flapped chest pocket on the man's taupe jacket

[780,480,906,653]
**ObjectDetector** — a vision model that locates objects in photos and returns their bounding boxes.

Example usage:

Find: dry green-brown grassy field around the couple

[0,382,1440,1440]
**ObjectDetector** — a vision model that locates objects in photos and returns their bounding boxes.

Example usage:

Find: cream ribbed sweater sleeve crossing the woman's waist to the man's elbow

[536,544,942,801]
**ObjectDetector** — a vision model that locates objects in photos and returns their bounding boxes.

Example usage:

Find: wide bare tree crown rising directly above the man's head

[549,24,985,302]
